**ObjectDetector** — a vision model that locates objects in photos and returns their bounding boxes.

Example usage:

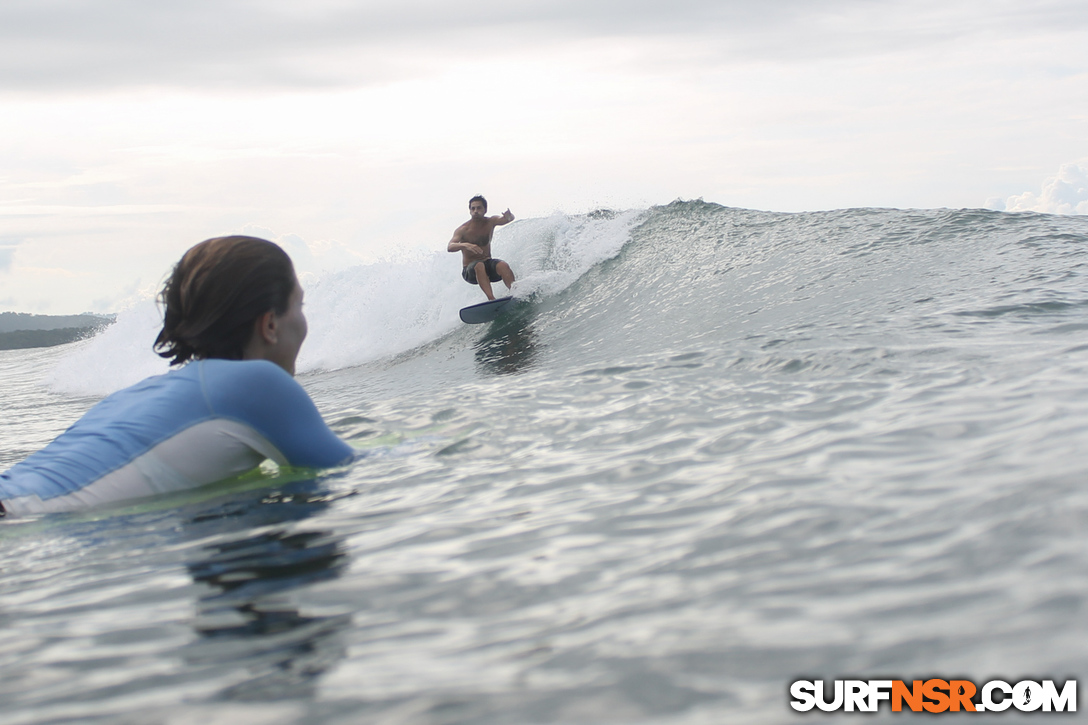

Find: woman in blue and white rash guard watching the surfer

[0,236,355,515]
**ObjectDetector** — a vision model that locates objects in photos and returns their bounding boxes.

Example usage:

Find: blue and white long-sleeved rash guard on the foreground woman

[0,360,355,515]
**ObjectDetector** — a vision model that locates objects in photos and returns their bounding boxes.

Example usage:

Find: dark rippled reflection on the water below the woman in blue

[178,481,351,700]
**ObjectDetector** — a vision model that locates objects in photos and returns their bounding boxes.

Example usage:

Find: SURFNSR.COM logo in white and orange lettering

[790,679,1077,713]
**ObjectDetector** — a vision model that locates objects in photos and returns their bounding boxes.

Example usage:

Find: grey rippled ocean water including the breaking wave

[0,201,1088,725]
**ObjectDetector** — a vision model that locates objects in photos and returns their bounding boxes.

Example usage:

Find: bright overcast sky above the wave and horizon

[0,0,1088,314]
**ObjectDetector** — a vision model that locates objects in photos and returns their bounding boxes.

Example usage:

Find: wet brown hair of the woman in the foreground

[153,236,298,365]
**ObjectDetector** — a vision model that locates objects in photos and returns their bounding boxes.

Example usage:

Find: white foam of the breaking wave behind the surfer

[48,211,644,395]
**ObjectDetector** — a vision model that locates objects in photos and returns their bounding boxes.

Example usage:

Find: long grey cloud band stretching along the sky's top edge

[0,0,1088,93]
